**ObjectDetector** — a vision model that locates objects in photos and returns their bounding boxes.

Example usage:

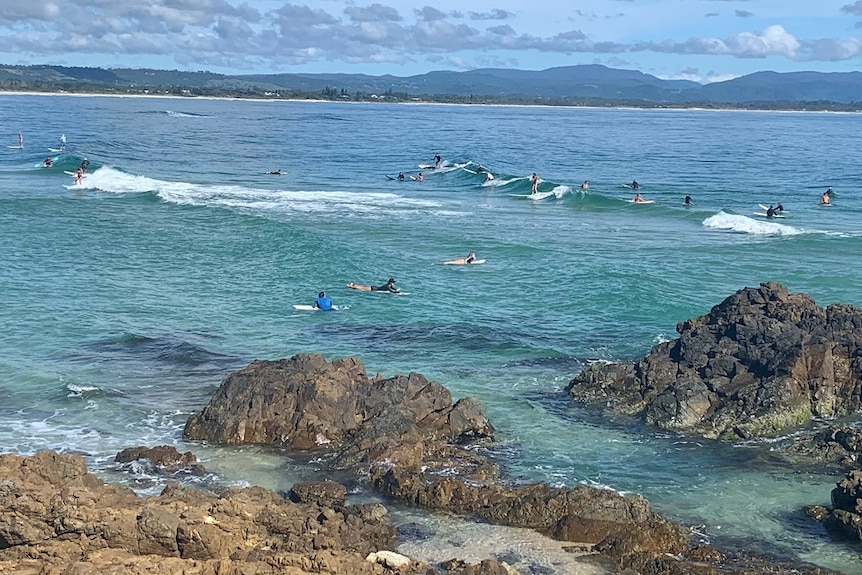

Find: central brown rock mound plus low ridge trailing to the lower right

[185,355,820,573]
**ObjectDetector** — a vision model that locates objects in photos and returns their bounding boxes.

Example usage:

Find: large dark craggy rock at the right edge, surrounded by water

[567,283,862,439]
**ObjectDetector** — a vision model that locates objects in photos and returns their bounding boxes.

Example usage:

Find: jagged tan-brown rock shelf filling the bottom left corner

[0,451,434,575]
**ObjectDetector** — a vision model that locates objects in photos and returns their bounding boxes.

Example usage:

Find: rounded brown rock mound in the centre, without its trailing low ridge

[184,354,494,476]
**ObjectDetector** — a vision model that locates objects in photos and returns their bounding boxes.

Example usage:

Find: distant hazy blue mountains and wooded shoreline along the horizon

[0,64,862,108]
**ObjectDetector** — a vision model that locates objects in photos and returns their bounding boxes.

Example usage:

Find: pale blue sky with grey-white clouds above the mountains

[0,0,862,82]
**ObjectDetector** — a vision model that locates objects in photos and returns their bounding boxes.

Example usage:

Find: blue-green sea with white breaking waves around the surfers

[0,95,862,573]
